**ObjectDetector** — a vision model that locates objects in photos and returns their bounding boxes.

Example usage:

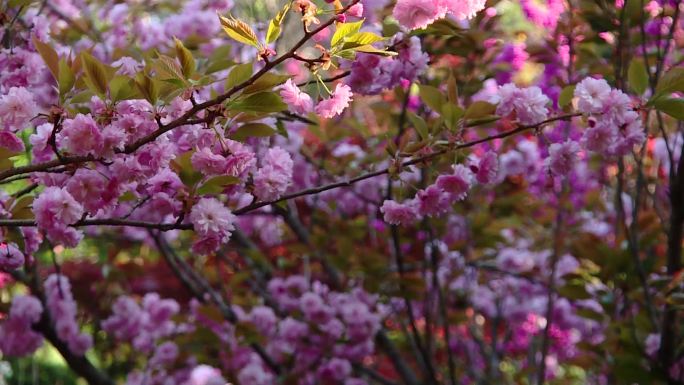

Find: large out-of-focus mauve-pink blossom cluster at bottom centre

[215,275,382,385]
